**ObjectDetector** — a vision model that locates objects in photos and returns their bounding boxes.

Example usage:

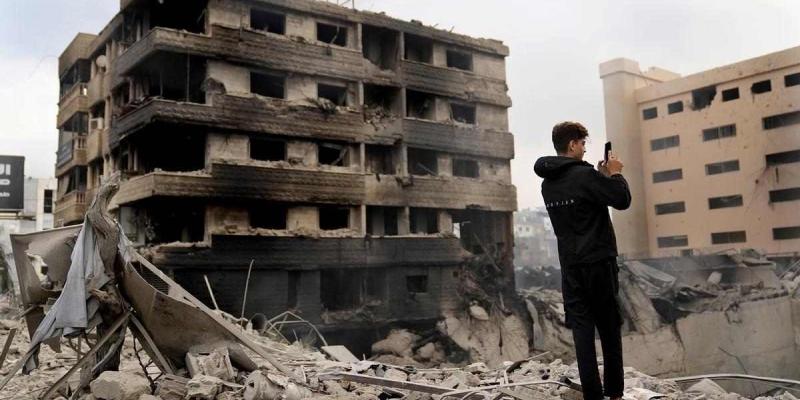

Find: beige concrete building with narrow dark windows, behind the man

[600,47,800,257]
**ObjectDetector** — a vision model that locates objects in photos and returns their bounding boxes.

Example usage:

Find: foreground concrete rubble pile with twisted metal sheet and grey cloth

[0,182,797,400]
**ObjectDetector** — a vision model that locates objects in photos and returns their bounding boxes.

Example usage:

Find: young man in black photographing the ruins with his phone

[534,122,631,400]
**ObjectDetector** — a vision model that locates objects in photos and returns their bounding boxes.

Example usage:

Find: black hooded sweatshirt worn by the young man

[533,156,631,268]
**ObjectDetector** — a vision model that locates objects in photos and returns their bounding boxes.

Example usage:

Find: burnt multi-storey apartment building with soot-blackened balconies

[55,0,516,346]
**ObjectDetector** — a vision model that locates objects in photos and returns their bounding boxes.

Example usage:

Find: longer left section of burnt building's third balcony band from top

[113,163,364,205]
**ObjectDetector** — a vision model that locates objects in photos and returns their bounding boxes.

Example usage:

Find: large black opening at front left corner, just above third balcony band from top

[134,123,206,173]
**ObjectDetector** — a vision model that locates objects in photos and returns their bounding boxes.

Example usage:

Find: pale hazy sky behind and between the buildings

[0,0,800,209]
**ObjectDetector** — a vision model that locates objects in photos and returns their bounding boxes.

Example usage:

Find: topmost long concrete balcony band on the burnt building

[111,25,511,107]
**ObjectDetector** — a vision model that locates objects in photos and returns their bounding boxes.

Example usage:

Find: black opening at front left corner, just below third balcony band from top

[145,203,205,244]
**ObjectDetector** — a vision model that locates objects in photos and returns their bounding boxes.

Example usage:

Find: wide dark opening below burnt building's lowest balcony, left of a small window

[320,268,386,311]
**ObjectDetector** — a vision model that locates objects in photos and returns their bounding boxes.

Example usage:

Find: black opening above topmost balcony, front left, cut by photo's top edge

[149,0,207,33]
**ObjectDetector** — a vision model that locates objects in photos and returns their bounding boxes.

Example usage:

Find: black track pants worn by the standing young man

[561,259,624,400]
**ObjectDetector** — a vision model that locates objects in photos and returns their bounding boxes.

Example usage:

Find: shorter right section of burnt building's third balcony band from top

[364,175,517,211]
